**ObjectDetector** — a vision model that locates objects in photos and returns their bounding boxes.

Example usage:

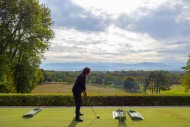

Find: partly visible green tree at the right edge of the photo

[181,55,190,92]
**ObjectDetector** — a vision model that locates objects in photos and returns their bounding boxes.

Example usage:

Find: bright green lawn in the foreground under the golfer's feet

[0,107,190,127]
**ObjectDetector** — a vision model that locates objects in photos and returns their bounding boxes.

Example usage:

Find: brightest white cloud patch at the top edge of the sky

[73,0,169,15]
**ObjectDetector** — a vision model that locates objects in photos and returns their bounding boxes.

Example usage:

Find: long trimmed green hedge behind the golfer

[0,94,190,106]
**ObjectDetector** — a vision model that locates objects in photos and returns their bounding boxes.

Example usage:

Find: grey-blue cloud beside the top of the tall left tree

[40,0,110,31]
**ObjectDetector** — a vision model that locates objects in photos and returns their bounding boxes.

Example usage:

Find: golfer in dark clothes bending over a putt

[72,67,90,122]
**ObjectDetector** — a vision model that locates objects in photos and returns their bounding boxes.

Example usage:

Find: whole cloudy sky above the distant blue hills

[40,0,190,65]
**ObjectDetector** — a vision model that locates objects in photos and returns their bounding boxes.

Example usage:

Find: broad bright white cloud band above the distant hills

[43,25,174,63]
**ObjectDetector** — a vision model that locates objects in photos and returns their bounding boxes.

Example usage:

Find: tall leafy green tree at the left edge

[0,0,53,92]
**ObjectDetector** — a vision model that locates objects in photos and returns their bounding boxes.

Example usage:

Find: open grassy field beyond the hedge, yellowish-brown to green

[32,83,190,96]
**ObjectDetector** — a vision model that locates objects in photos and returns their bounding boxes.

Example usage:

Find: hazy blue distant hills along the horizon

[40,62,182,71]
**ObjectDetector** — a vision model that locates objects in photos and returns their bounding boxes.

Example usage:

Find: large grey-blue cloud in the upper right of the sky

[115,1,190,43]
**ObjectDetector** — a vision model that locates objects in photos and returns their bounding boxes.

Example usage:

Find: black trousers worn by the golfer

[73,91,82,117]
